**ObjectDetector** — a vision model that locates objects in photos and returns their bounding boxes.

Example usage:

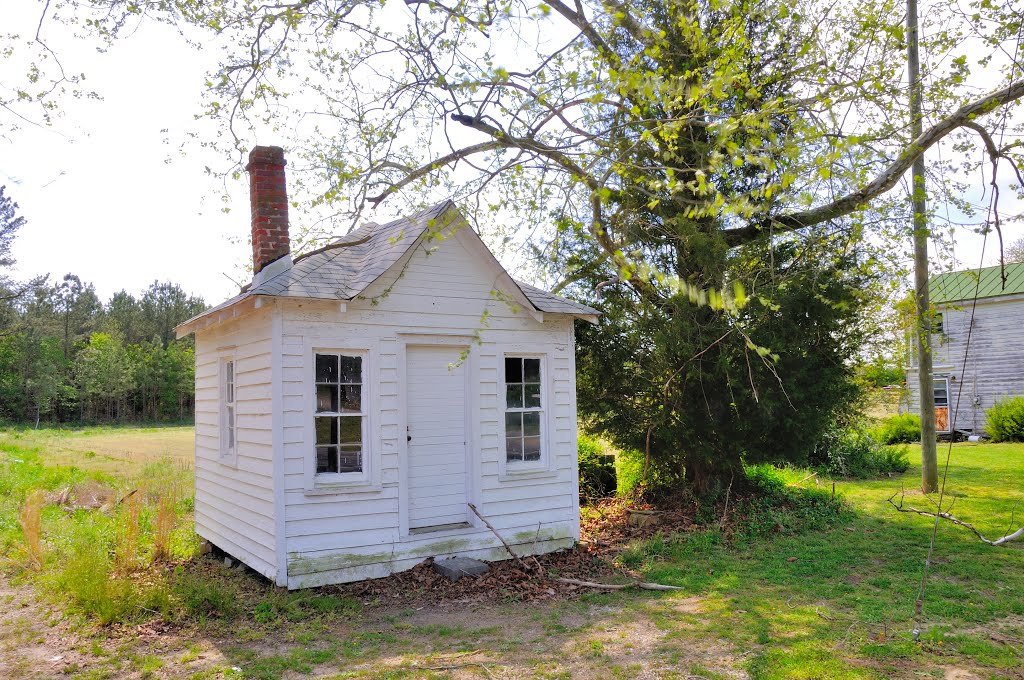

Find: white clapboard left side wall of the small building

[196,307,278,579]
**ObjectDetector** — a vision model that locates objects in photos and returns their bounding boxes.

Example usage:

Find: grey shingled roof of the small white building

[179,201,600,328]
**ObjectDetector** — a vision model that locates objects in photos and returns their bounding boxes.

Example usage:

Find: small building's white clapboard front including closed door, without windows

[272,225,579,586]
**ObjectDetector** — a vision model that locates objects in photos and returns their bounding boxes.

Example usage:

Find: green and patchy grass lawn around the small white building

[0,428,1024,678]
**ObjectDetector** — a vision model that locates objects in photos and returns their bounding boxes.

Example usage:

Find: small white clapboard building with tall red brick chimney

[177,146,597,589]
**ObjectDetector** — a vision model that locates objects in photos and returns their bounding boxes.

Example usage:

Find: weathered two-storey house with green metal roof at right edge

[905,263,1024,434]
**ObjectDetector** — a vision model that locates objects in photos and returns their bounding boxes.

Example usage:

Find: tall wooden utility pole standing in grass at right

[906,0,939,494]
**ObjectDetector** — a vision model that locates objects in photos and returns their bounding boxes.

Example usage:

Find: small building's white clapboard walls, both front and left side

[196,218,579,588]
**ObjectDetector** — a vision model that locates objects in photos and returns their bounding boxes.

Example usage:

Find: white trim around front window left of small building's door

[301,336,382,495]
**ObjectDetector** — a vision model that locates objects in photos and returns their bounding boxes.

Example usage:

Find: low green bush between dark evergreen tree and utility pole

[812,420,910,479]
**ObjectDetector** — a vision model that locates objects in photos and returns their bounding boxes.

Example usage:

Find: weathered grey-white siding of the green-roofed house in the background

[906,295,1024,432]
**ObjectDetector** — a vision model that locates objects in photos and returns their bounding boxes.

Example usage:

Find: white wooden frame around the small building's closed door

[397,332,482,541]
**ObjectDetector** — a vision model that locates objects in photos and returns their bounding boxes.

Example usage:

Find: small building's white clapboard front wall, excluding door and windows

[278,229,579,588]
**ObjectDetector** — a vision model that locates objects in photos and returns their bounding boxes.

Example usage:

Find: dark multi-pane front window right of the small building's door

[504,356,544,463]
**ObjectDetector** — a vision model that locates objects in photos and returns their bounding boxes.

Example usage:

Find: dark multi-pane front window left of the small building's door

[313,353,365,473]
